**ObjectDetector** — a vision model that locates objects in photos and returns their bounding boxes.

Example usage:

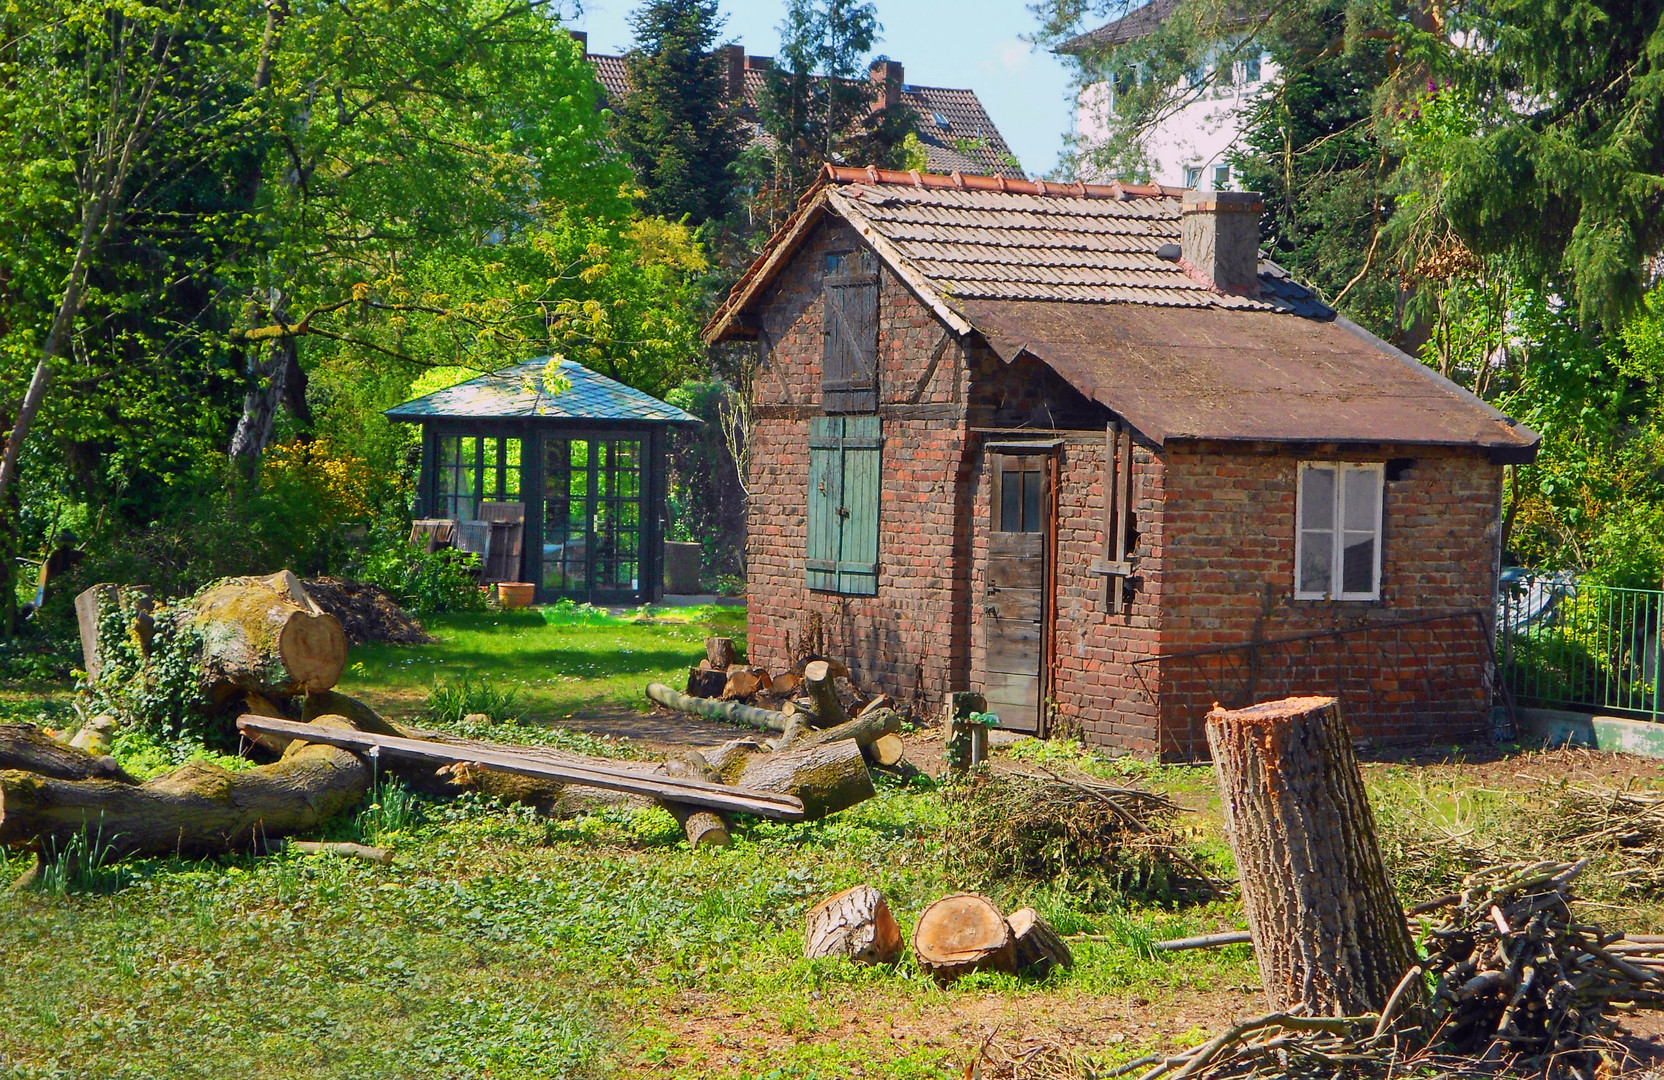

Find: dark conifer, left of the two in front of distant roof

[617,0,740,226]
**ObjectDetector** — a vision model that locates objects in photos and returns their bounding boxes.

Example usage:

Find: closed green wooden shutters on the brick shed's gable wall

[804,416,884,596]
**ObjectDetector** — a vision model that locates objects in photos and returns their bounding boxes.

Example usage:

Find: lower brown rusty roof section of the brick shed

[963,300,1539,461]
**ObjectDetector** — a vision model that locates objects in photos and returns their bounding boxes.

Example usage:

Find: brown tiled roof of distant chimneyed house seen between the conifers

[589,53,1023,180]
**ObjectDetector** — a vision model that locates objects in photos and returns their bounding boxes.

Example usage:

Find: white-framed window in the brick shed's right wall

[1295,461,1384,601]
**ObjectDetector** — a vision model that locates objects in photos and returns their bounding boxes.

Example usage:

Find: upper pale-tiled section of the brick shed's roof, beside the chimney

[835,181,1333,318]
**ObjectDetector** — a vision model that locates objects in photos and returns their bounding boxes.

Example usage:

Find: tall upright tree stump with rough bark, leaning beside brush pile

[1206,697,1416,1017]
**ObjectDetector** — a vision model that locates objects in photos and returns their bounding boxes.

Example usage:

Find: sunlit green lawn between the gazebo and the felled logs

[339,604,745,721]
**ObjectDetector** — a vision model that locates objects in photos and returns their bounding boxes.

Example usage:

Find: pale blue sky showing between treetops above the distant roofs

[567,0,1073,176]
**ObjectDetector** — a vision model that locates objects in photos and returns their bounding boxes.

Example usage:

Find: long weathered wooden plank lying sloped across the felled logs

[236,716,804,820]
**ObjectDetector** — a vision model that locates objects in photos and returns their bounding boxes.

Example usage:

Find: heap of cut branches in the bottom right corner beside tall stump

[1128,862,1664,1080]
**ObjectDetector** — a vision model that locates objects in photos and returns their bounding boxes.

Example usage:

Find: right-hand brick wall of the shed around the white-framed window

[1160,446,1501,757]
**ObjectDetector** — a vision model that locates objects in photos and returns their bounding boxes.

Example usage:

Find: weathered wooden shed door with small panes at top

[980,454,1052,734]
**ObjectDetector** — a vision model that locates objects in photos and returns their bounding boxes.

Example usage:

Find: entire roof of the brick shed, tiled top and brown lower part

[706,166,1539,461]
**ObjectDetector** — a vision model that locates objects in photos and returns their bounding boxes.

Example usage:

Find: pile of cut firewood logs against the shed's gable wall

[647,637,907,767]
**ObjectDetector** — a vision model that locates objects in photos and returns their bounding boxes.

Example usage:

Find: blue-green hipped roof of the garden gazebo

[386,356,699,424]
